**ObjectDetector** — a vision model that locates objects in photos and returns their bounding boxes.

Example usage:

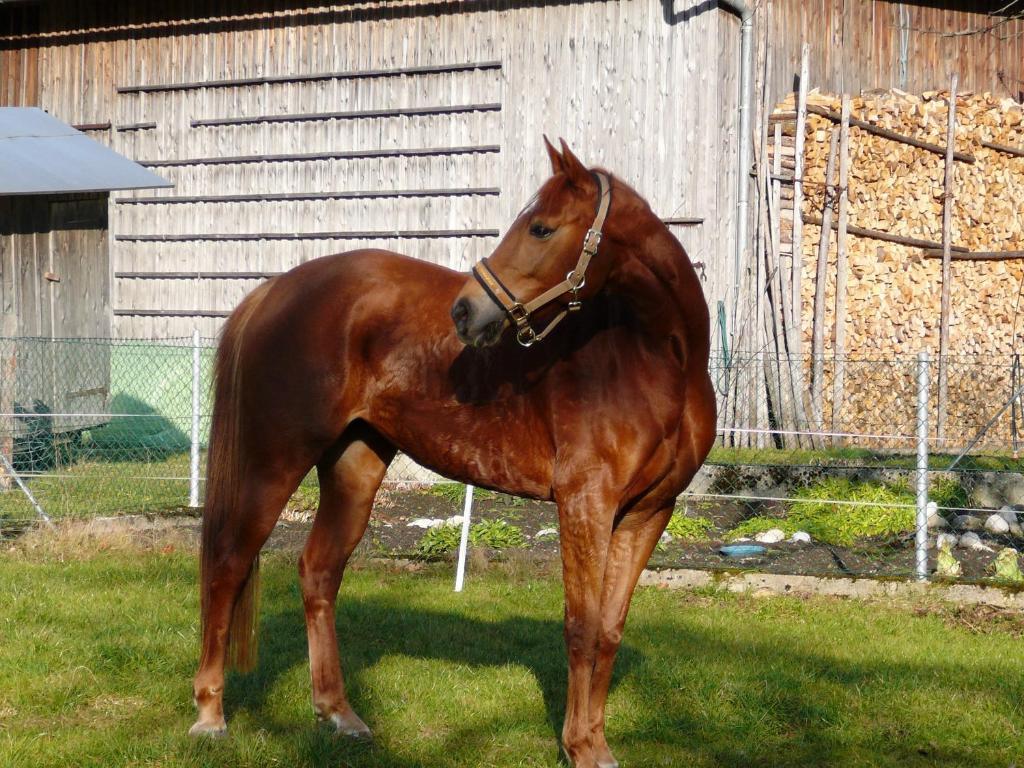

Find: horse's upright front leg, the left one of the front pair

[558,488,617,768]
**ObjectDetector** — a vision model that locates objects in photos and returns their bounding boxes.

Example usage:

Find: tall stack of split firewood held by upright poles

[769,91,1024,442]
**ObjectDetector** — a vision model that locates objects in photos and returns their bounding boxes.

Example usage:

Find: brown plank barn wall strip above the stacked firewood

[758,0,1024,102]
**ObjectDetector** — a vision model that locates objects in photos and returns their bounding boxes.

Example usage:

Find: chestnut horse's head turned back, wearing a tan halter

[452,138,611,347]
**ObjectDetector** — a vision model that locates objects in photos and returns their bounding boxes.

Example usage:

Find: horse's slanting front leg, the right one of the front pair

[590,505,673,768]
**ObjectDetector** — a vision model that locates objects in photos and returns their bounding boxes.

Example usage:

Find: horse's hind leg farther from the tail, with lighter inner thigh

[299,423,394,738]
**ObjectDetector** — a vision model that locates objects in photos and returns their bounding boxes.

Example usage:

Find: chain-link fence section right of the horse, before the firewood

[696,353,1024,581]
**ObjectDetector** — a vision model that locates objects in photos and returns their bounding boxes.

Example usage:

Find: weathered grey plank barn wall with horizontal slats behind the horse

[0,0,738,336]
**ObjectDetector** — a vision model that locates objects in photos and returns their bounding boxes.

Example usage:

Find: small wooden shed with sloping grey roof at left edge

[0,108,171,439]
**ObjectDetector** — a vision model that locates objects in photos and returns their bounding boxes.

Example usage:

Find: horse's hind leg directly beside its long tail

[188,472,304,736]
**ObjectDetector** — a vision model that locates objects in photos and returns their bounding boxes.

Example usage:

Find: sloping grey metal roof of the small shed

[0,106,173,195]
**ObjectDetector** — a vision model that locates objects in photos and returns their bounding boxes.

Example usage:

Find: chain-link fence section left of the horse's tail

[0,339,213,520]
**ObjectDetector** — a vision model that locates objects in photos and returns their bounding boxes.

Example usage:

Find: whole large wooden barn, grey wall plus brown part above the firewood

[0,0,1024,346]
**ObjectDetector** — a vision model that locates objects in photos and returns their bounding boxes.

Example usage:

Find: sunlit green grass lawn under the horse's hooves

[0,549,1024,768]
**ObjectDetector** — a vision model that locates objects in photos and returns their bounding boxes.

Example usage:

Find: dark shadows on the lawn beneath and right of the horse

[205,581,1024,768]
